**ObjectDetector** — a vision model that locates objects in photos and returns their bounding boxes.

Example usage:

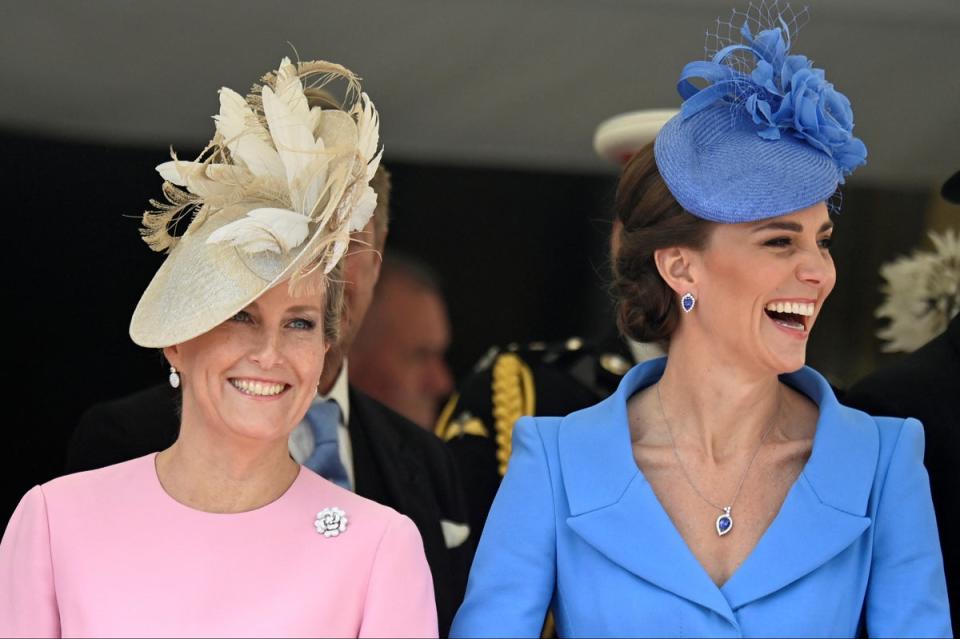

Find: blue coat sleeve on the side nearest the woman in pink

[450,417,556,637]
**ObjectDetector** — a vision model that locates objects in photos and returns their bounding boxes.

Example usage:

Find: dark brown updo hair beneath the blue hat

[611,142,713,343]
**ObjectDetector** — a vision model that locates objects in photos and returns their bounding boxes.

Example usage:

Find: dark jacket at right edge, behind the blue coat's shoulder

[843,316,960,634]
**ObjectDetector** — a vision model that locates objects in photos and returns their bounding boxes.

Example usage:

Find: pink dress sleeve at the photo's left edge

[0,486,60,637]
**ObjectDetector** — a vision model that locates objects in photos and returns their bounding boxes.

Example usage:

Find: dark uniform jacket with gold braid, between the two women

[436,334,648,537]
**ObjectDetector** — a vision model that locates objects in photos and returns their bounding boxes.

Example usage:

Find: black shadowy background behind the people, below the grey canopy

[0,131,944,522]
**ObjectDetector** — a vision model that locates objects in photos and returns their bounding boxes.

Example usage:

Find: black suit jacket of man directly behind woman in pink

[67,385,479,636]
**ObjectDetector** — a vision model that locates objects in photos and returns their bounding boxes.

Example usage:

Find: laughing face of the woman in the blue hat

[675,203,837,374]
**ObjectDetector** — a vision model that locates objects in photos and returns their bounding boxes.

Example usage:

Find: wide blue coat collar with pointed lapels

[559,358,880,624]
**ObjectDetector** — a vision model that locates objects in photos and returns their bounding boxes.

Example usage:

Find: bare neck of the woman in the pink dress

[156,419,300,513]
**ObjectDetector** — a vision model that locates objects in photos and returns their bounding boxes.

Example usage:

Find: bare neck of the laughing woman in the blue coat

[658,340,789,462]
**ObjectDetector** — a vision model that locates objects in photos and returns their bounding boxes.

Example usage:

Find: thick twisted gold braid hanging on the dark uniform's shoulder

[492,353,536,477]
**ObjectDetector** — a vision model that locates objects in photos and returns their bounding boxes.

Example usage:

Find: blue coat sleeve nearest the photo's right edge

[866,419,952,637]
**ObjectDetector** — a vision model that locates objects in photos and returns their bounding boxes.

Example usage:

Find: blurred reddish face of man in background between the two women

[349,273,453,430]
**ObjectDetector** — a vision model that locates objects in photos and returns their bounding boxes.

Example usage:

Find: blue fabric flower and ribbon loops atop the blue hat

[677,18,867,183]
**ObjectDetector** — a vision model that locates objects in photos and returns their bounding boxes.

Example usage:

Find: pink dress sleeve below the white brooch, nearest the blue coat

[359,517,438,637]
